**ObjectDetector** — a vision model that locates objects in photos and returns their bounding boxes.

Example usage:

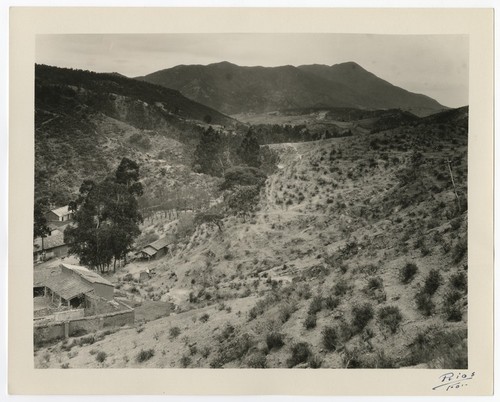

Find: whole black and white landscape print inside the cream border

[29,33,469,370]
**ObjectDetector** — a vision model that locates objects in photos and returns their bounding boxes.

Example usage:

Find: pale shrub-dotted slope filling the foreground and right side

[35,109,468,369]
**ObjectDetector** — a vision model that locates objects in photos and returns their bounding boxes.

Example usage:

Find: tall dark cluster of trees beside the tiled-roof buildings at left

[64,158,143,272]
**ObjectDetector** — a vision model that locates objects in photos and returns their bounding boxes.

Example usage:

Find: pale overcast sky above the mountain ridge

[36,34,469,107]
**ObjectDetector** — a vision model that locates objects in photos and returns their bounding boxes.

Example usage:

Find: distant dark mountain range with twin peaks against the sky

[137,62,445,114]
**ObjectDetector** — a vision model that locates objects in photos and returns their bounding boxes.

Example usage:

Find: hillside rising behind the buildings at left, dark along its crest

[35,65,236,205]
